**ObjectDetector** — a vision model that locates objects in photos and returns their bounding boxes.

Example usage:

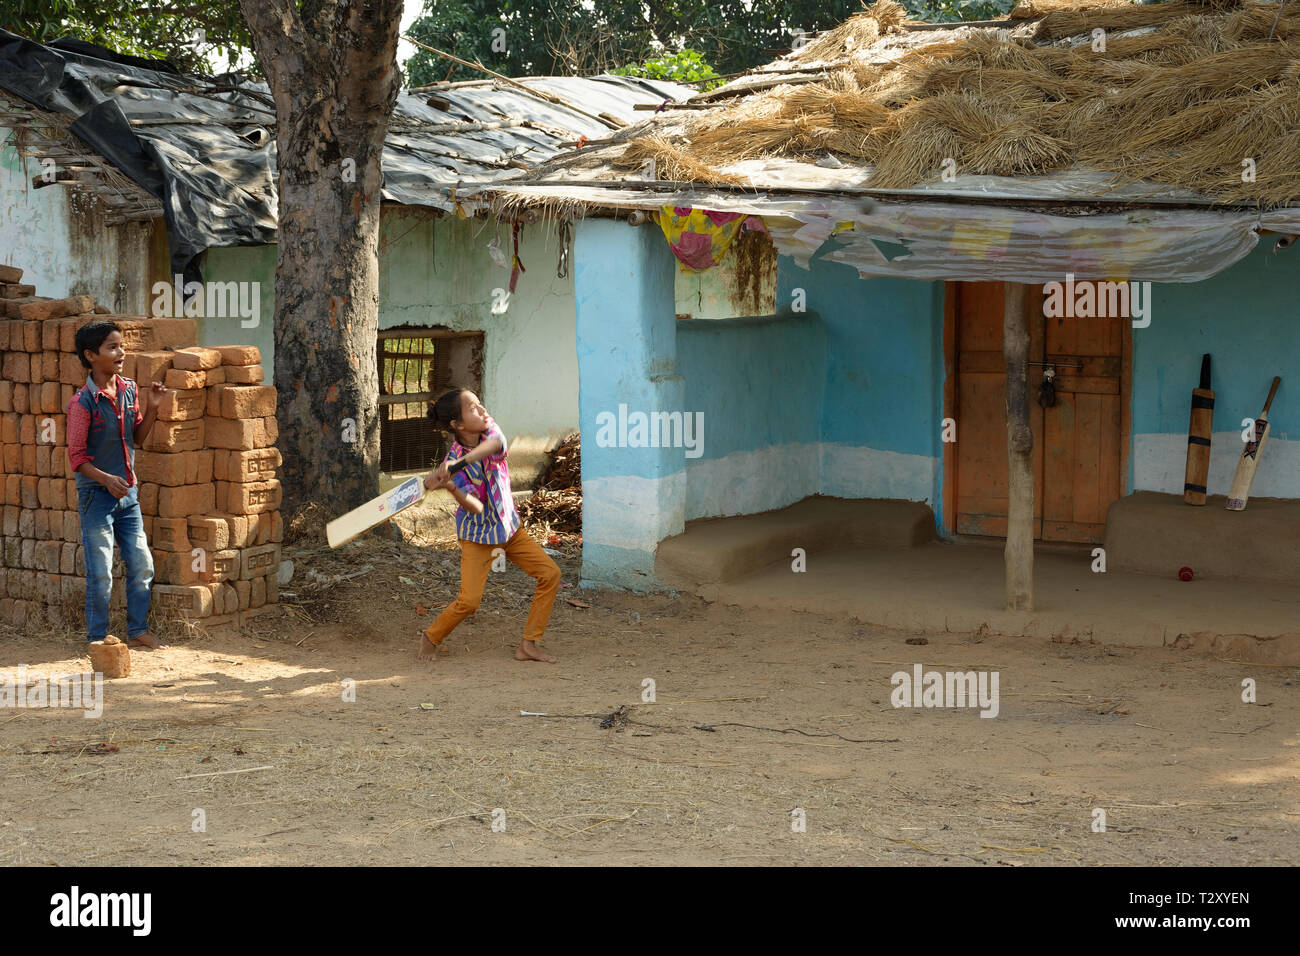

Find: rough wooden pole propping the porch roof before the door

[1002,282,1034,611]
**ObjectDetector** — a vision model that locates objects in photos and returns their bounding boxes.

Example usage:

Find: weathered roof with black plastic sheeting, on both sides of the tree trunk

[0,30,694,269]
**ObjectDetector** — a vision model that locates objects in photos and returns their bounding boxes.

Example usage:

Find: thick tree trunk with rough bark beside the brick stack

[239,0,402,515]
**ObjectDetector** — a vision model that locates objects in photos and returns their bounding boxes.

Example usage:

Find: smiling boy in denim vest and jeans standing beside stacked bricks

[66,321,166,650]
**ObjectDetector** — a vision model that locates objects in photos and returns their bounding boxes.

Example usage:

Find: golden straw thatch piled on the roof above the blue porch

[623,0,1300,207]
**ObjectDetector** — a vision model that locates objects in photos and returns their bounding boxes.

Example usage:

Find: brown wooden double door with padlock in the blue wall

[948,282,1128,542]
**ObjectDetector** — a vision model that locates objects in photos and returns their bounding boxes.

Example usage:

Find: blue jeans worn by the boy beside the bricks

[77,485,153,641]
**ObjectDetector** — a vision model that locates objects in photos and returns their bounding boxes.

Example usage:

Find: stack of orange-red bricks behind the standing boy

[0,265,283,627]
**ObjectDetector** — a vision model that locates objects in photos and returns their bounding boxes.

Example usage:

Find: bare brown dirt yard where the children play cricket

[0,528,1300,866]
